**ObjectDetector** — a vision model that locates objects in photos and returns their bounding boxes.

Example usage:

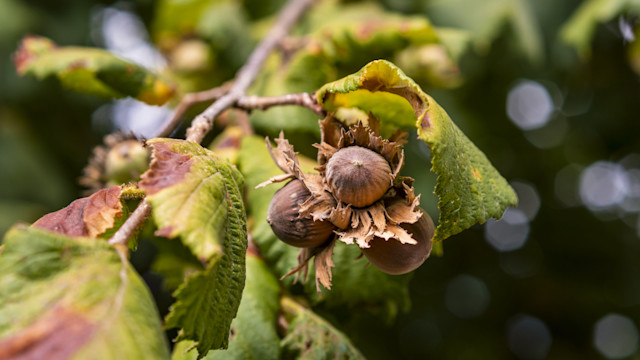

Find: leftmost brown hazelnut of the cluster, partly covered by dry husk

[267,180,336,247]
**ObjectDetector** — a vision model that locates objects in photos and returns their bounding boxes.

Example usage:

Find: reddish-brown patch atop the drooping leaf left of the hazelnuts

[138,143,193,195]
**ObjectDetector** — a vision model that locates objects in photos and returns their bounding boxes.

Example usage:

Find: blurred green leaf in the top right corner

[560,0,640,56]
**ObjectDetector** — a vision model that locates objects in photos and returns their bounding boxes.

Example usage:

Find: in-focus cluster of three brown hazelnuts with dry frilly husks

[258,115,434,291]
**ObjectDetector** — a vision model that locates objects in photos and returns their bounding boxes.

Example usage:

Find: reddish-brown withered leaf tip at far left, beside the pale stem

[32,186,122,237]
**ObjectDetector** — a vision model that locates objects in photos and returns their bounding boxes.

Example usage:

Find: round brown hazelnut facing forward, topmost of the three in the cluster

[326,146,393,208]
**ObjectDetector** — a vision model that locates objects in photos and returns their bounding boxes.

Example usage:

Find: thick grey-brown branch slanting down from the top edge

[187,0,314,143]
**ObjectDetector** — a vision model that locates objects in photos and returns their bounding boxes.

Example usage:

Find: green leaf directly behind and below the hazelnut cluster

[238,134,409,314]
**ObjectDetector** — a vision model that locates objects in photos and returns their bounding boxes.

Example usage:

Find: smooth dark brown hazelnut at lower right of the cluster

[362,209,435,275]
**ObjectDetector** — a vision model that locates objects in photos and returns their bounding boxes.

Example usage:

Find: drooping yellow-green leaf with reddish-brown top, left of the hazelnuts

[140,139,247,356]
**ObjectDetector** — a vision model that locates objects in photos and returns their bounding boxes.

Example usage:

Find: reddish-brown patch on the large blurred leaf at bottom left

[0,306,96,360]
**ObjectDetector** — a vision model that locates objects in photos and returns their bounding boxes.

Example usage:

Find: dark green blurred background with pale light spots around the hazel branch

[0,0,640,359]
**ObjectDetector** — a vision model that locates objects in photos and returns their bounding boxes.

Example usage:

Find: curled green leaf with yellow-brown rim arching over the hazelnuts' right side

[316,60,517,241]
